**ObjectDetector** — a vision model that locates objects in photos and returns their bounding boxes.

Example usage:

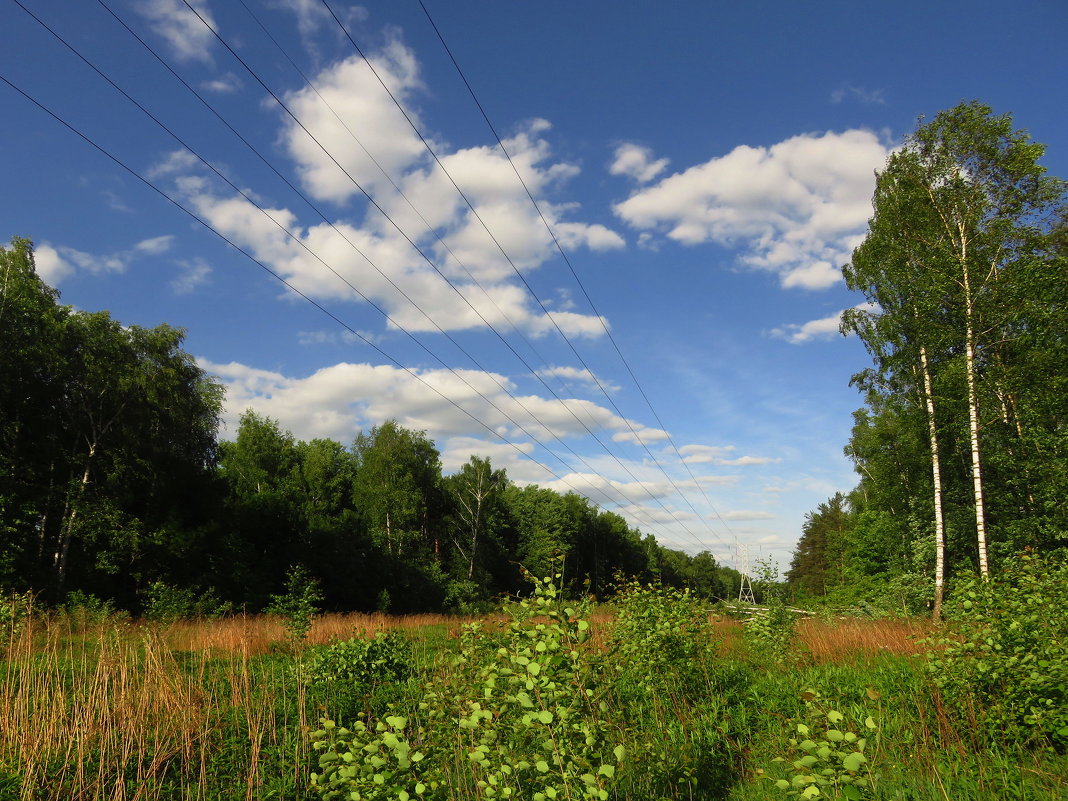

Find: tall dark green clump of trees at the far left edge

[0,239,221,597]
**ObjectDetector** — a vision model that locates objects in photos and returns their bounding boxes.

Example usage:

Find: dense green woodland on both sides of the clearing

[0,103,1068,616]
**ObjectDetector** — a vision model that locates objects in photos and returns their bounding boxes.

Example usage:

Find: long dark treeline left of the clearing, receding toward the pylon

[0,239,738,612]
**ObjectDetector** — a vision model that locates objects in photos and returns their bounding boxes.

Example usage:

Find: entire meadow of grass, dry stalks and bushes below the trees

[0,554,1068,801]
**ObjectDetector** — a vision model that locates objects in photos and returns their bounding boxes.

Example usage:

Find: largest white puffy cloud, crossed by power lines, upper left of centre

[152,40,625,337]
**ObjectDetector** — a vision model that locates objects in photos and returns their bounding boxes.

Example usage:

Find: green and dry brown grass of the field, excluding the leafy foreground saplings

[0,608,1068,801]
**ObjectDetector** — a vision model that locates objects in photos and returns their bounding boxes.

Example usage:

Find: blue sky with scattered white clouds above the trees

[0,0,1068,564]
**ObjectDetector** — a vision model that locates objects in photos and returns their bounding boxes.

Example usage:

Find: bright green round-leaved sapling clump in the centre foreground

[313,574,624,801]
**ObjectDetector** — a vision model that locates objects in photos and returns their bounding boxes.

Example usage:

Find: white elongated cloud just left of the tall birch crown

[614,129,890,289]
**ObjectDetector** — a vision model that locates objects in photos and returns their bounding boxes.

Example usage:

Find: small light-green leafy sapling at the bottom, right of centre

[771,691,878,801]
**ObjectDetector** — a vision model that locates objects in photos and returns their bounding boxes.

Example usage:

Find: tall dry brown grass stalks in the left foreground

[0,617,308,801]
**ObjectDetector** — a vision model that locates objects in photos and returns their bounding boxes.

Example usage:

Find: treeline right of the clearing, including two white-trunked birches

[787,103,1068,616]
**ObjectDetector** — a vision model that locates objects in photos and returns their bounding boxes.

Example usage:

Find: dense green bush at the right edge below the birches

[928,553,1068,749]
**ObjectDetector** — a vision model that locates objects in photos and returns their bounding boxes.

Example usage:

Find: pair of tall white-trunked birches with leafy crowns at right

[846,103,1064,576]
